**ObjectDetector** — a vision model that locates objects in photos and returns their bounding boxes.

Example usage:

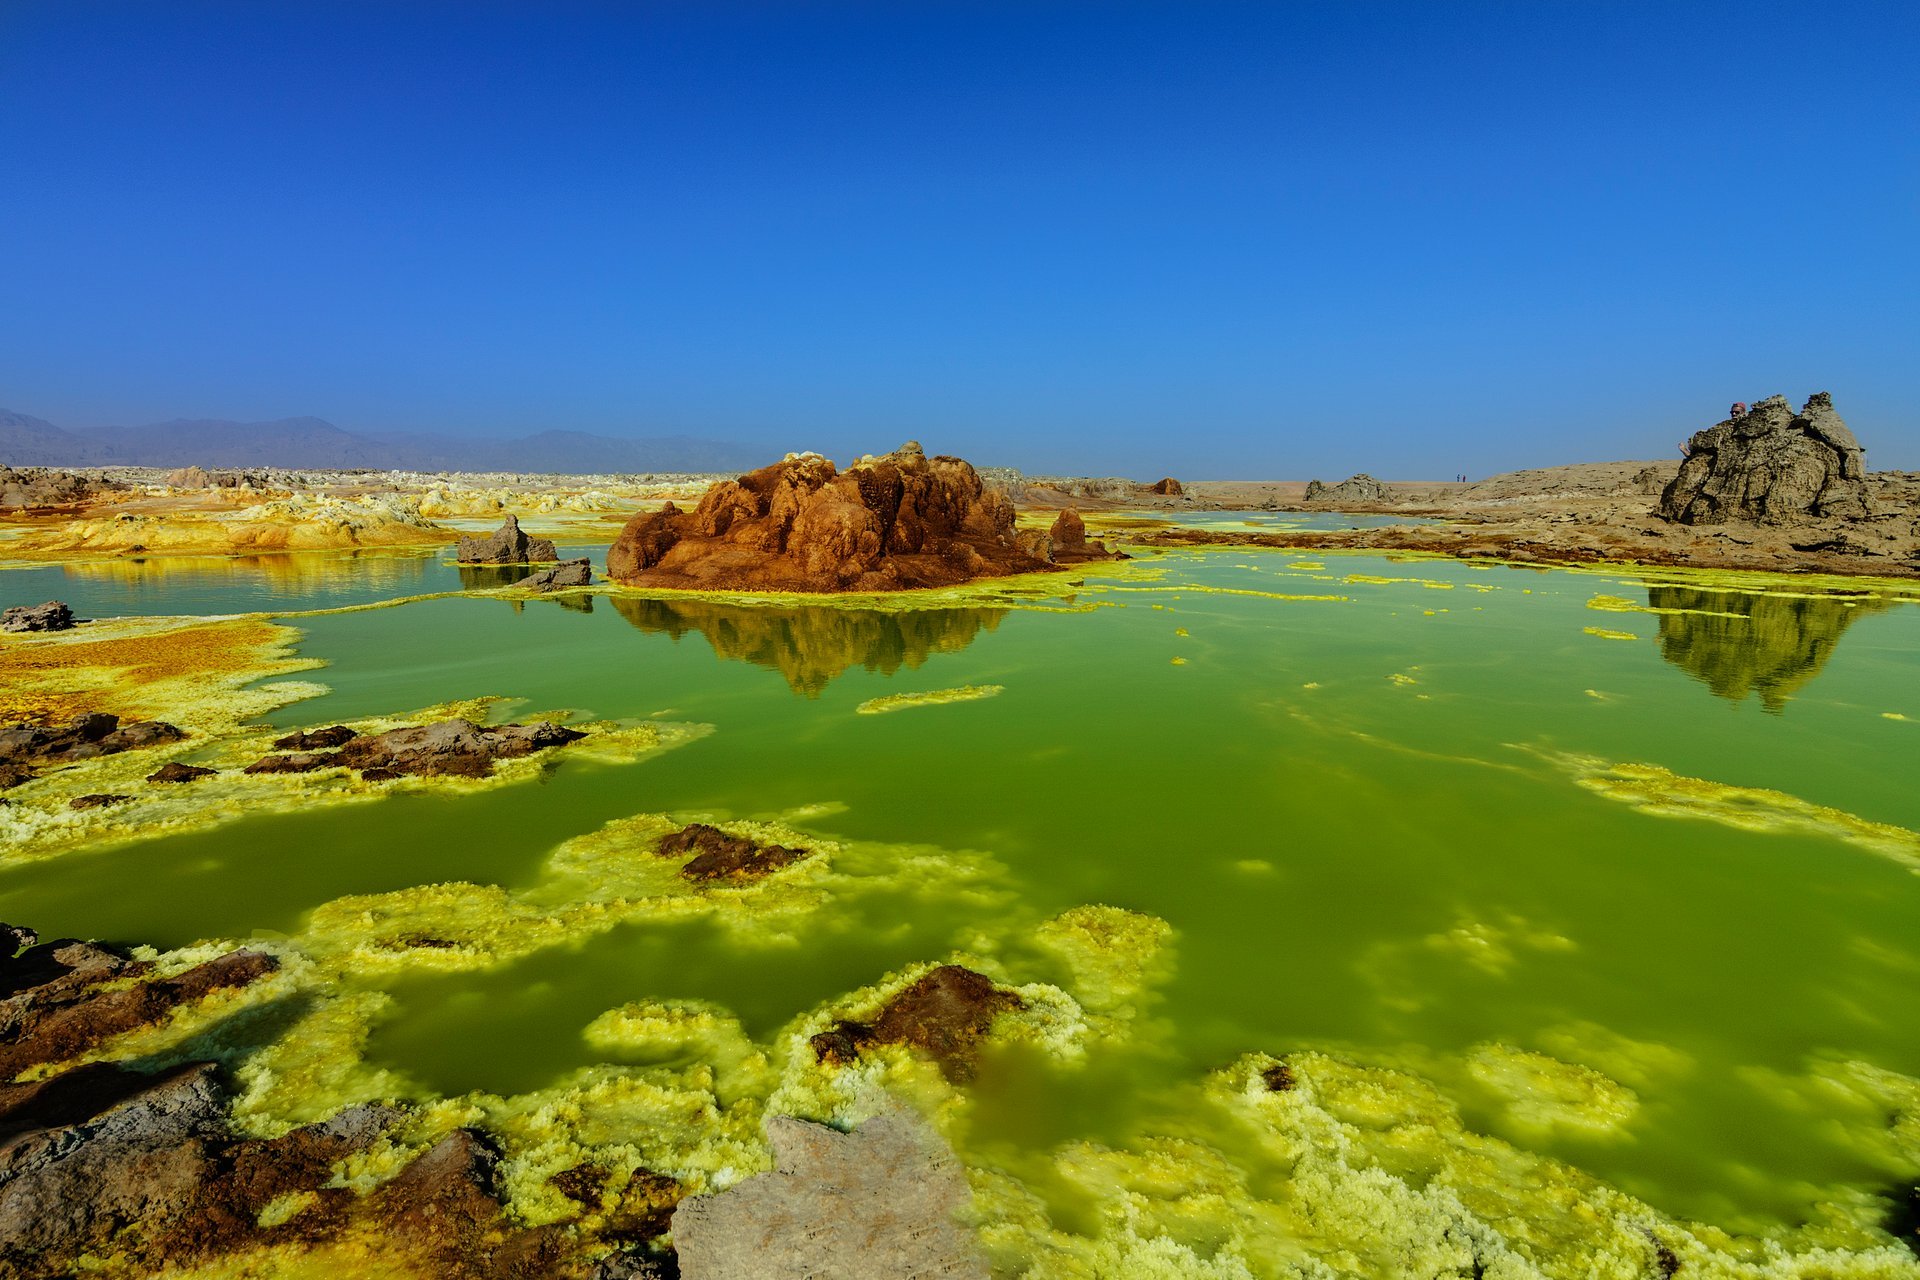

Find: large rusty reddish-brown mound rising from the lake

[607,441,1110,591]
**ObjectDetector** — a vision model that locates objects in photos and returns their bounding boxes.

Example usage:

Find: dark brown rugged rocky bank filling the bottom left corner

[0,925,656,1280]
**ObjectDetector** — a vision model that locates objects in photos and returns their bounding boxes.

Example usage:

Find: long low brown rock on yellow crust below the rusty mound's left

[246,720,586,781]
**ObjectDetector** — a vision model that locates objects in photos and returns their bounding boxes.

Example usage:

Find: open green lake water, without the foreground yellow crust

[0,533,1920,1274]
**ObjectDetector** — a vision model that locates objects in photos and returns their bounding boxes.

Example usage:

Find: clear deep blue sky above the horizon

[0,0,1920,478]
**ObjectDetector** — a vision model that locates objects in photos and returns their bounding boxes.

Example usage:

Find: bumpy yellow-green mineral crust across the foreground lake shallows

[37,794,1920,1280]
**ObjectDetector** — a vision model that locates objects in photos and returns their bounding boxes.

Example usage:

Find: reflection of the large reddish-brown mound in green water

[609,595,1008,697]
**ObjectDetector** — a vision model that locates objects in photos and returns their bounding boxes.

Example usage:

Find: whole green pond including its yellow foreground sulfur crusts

[0,516,1920,1276]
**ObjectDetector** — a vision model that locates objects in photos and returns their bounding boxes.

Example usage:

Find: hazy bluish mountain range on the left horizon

[0,409,766,474]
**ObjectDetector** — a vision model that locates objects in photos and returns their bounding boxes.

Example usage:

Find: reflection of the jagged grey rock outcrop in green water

[1647,585,1887,714]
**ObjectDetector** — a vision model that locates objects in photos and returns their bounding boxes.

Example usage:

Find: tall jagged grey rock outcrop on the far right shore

[1655,391,1870,524]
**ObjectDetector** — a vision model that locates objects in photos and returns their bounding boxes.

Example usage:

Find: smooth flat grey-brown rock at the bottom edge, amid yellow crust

[674,1113,987,1280]
